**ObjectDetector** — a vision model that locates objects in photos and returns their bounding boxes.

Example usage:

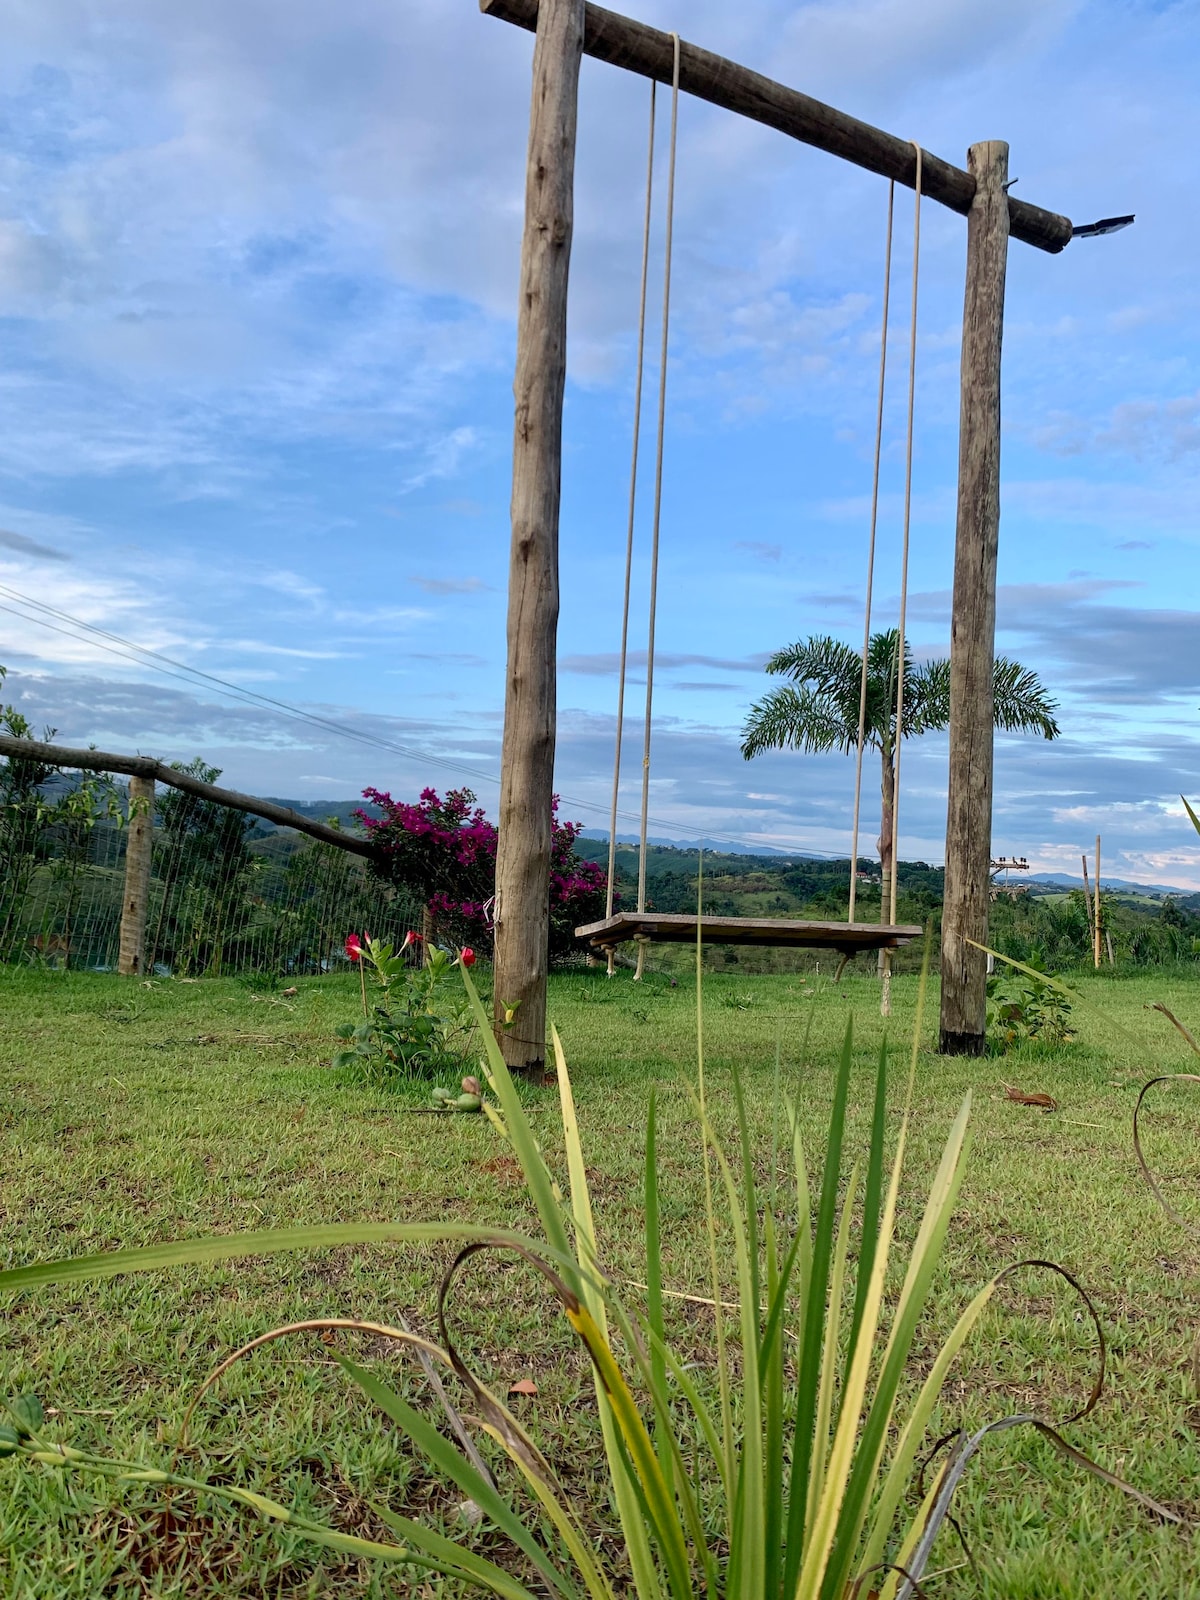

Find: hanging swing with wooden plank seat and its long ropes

[574,34,923,972]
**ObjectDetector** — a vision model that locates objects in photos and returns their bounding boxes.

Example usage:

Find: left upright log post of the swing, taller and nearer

[494,0,584,1072]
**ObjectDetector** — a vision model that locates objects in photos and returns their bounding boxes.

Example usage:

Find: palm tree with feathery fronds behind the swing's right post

[742,629,1059,922]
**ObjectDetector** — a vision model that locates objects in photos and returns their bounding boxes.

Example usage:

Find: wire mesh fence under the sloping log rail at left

[0,806,422,976]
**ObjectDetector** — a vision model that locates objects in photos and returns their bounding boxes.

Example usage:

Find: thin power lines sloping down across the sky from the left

[0,584,812,850]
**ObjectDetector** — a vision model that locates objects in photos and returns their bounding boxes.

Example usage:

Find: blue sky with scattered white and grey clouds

[0,0,1200,886]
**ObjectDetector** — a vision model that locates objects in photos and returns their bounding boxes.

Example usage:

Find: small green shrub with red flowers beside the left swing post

[333,933,474,1083]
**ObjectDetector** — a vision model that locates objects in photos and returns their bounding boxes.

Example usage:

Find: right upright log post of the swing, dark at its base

[939,139,1008,1056]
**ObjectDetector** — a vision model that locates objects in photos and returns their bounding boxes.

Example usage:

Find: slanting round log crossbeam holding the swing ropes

[480,0,1072,254]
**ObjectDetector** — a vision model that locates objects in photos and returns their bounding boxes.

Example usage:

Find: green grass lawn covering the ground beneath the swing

[0,970,1200,1600]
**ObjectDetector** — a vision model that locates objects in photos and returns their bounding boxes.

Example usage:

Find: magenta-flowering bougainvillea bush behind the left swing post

[357,789,606,960]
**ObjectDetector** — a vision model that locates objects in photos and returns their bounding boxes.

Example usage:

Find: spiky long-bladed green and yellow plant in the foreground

[0,971,1017,1600]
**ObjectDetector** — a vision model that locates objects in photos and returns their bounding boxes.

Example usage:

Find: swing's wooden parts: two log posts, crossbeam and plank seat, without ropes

[480,0,1131,1070]
